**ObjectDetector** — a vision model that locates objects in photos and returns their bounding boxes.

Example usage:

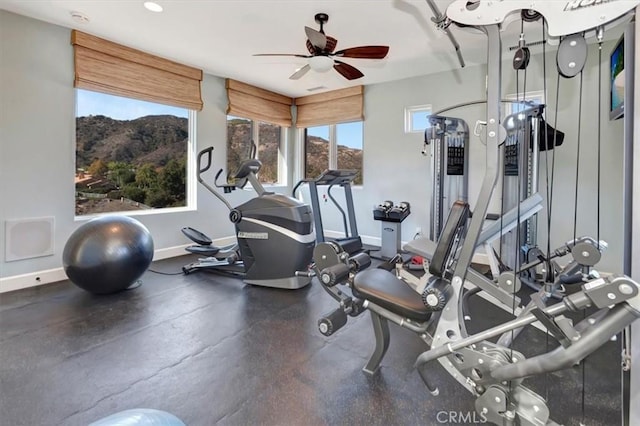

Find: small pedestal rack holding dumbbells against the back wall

[370,201,411,260]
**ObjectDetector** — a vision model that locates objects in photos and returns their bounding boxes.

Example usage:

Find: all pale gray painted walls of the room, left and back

[0,11,622,277]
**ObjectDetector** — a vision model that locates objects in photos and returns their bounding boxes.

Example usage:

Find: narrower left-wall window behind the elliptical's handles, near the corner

[227,115,284,184]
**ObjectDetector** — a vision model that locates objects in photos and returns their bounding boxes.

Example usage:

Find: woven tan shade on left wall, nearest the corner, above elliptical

[226,79,293,127]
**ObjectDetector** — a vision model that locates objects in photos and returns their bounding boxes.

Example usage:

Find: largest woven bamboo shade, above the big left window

[71,30,202,111]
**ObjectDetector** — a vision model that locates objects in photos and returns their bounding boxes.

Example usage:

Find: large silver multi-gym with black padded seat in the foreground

[313,0,640,426]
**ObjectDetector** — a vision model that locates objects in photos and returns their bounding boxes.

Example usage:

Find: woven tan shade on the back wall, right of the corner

[295,86,364,128]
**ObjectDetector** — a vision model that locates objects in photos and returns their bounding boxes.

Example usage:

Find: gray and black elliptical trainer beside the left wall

[182,147,315,290]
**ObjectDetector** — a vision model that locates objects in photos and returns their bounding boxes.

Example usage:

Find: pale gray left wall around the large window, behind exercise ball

[0,11,248,277]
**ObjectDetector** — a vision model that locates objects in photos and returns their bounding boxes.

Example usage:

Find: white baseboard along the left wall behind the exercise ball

[0,237,235,294]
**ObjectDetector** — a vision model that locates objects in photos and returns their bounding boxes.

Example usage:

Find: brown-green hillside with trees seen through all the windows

[75,115,362,215]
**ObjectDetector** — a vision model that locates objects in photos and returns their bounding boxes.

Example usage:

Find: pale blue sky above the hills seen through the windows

[76,89,363,149]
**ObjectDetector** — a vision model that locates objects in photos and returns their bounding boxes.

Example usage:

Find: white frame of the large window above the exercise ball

[71,87,198,218]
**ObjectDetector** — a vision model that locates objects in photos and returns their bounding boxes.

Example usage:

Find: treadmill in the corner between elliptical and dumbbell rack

[292,170,362,253]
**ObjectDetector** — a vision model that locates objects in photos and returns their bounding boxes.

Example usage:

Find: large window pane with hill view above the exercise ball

[75,89,195,216]
